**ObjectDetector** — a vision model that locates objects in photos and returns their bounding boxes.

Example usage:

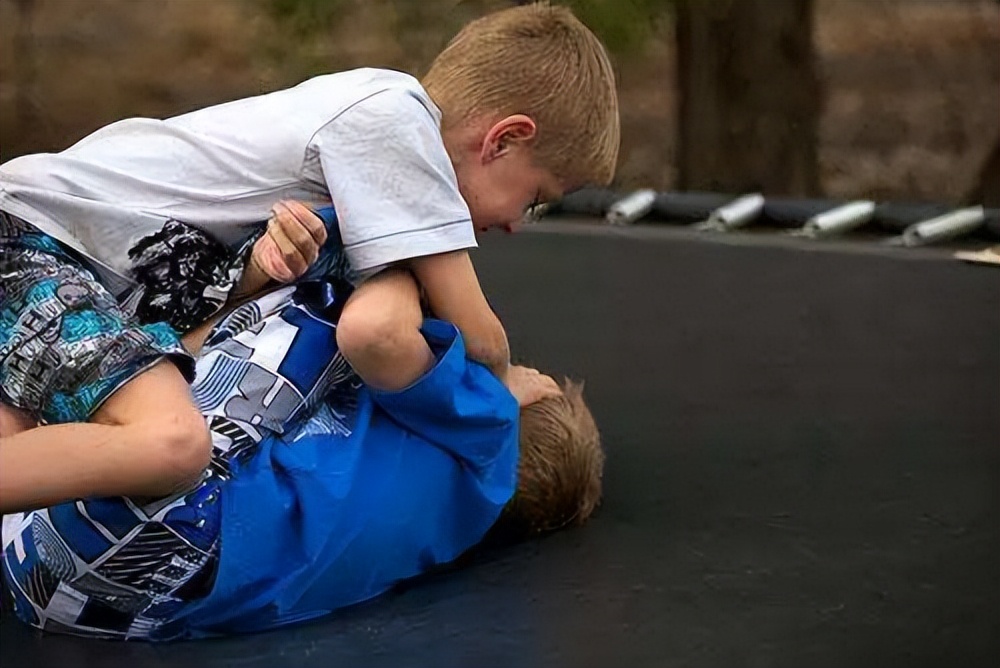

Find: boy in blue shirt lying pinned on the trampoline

[3,271,603,640]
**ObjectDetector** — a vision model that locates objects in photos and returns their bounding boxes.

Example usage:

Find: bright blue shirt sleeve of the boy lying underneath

[371,319,520,472]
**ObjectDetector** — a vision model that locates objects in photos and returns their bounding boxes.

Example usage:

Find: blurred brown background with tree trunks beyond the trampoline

[0,0,1000,206]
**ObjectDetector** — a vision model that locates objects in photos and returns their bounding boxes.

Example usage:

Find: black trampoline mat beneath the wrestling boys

[0,223,1000,668]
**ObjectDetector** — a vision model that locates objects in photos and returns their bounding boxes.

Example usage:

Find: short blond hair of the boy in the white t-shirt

[422,3,621,188]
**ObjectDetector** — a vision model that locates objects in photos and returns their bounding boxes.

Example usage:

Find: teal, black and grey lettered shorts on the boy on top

[0,213,194,424]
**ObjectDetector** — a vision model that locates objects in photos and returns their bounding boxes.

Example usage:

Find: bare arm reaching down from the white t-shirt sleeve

[408,251,510,383]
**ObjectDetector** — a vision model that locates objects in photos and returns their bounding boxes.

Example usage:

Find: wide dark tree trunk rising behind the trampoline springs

[676,0,820,195]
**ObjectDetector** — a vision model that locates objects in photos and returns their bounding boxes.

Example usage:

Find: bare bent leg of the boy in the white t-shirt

[0,360,211,513]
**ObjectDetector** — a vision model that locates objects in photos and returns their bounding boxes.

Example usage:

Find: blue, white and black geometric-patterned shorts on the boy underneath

[0,281,361,640]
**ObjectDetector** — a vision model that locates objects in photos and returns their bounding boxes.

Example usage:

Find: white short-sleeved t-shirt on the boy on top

[0,69,476,284]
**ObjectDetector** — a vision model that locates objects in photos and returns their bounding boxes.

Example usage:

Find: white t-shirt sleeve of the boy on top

[310,88,476,276]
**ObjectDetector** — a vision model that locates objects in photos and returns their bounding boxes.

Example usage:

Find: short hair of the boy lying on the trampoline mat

[494,381,604,539]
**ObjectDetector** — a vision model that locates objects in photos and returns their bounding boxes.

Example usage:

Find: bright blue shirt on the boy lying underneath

[172,320,518,636]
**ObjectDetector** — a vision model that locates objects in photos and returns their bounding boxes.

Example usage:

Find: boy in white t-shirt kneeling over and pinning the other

[0,5,619,512]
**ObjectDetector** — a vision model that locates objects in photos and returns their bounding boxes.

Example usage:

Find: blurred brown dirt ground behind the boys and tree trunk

[0,0,1000,201]
